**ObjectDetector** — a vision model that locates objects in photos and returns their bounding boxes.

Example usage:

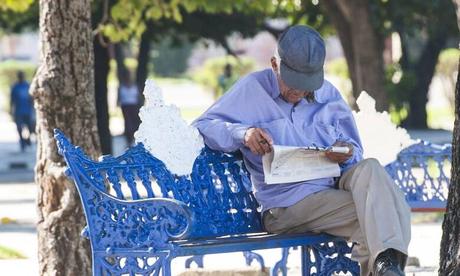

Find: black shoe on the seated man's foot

[373,248,405,276]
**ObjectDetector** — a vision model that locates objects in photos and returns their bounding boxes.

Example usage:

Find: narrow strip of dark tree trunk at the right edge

[438,55,460,275]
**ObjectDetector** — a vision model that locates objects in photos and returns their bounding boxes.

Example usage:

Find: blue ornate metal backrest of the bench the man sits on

[55,131,263,238]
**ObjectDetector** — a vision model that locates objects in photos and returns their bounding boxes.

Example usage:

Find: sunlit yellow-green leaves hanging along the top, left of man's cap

[103,0,302,41]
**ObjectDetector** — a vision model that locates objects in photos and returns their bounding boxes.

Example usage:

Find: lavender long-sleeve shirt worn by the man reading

[193,69,362,211]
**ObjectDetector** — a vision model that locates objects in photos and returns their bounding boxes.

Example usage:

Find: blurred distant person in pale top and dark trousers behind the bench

[117,71,142,146]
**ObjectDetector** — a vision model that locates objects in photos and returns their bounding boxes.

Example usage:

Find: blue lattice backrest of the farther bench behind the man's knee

[385,141,452,212]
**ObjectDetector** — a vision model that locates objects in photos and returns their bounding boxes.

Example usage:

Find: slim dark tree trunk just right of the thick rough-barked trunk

[94,36,112,154]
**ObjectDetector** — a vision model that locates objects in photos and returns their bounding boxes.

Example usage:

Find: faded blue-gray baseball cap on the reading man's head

[278,25,326,91]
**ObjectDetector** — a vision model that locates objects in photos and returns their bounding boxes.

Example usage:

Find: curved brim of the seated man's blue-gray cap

[280,62,324,91]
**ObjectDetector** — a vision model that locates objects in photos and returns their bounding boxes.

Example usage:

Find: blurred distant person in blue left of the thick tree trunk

[10,71,35,151]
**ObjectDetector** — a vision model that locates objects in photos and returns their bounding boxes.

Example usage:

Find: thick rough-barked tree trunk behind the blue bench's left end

[31,0,99,275]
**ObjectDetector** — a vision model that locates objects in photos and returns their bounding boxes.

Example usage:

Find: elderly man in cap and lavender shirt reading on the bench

[193,26,410,275]
